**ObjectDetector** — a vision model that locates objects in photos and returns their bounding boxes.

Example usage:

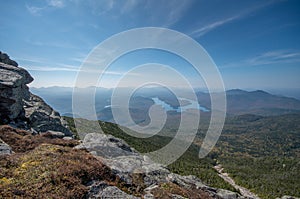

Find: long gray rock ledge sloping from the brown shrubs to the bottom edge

[76,133,251,199]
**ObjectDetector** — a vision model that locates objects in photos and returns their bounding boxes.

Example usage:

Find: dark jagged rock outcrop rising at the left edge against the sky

[0,53,72,136]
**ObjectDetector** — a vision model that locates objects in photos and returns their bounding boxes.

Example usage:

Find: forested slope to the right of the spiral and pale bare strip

[210,114,300,199]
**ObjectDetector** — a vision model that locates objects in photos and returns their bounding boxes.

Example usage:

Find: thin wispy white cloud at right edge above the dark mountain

[221,50,300,68]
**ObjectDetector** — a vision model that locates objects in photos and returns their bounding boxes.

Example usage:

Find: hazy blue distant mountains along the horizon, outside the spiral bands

[30,87,300,119]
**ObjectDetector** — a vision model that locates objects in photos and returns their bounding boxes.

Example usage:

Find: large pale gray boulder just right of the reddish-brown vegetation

[76,133,170,186]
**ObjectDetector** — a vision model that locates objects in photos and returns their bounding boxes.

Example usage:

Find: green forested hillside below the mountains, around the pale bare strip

[66,114,300,199]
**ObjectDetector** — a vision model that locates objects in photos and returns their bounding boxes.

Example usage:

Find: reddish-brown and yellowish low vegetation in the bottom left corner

[0,144,116,198]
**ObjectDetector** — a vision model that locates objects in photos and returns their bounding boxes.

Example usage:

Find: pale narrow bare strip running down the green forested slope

[214,164,260,199]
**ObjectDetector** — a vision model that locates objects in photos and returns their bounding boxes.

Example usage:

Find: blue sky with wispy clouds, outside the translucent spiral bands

[0,0,300,89]
